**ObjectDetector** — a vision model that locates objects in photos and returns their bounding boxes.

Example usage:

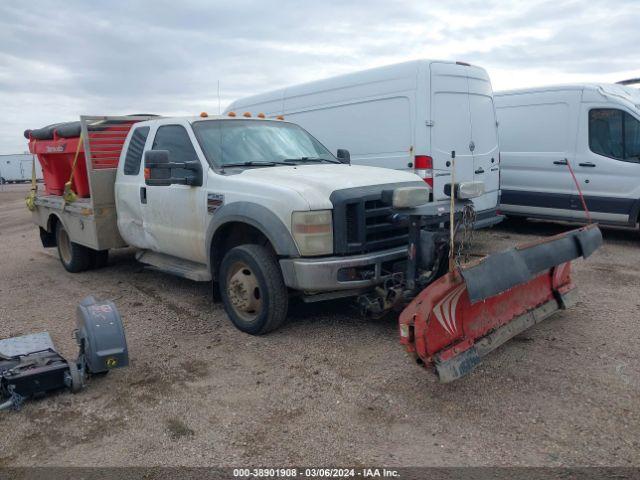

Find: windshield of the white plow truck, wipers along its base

[193,120,339,167]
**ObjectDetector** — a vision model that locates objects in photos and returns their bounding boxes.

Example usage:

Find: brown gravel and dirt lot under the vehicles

[0,186,640,466]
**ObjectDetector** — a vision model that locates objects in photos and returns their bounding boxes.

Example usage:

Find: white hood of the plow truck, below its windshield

[235,164,426,210]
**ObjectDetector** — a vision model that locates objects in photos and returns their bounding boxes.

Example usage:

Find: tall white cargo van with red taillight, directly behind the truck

[226,60,502,227]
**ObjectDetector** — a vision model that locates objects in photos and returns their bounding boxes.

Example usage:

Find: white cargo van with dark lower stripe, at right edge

[495,84,640,226]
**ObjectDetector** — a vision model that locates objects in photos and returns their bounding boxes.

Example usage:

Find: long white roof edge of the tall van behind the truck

[226,59,484,111]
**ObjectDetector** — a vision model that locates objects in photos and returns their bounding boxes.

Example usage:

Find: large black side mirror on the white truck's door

[144,150,202,187]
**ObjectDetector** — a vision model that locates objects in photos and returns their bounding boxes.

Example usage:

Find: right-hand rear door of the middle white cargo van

[465,66,500,212]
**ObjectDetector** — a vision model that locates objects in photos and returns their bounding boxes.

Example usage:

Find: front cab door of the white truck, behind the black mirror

[140,122,208,263]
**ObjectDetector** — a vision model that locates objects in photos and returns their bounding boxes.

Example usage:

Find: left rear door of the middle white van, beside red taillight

[427,62,475,201]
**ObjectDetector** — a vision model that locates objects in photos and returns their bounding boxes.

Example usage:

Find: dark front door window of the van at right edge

[589,108,640,162]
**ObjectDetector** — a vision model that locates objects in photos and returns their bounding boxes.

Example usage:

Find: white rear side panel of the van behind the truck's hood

[284,64,418,169]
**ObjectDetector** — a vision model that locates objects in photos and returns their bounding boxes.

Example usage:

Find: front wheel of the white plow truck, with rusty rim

[218,245,289,335]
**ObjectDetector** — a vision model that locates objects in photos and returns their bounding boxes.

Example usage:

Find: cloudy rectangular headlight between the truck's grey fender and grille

[291,210,333,256]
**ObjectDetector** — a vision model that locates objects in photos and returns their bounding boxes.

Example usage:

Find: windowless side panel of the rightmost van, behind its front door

[496,90,580,217]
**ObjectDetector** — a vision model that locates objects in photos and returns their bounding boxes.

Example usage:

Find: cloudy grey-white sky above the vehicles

[0,0,640,154]
